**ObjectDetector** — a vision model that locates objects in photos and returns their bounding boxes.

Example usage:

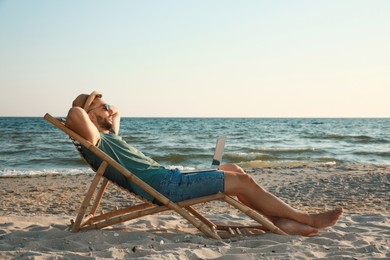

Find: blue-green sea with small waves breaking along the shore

[0,117,390,177]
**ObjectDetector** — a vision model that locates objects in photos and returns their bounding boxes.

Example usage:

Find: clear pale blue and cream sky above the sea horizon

[0,0,390,117]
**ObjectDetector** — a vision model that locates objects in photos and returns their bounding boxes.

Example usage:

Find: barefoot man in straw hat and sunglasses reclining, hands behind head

[66,91,343,236]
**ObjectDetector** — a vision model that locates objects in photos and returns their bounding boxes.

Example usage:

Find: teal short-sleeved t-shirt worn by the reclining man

[82,131,168,201]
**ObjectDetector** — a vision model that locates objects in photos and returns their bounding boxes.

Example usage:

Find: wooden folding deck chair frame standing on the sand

[44,114,286,240]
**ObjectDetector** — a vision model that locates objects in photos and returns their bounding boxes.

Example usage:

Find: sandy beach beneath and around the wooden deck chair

[0,165,390,259]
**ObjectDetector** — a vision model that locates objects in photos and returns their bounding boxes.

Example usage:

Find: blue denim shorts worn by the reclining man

[157,169,224,204]
